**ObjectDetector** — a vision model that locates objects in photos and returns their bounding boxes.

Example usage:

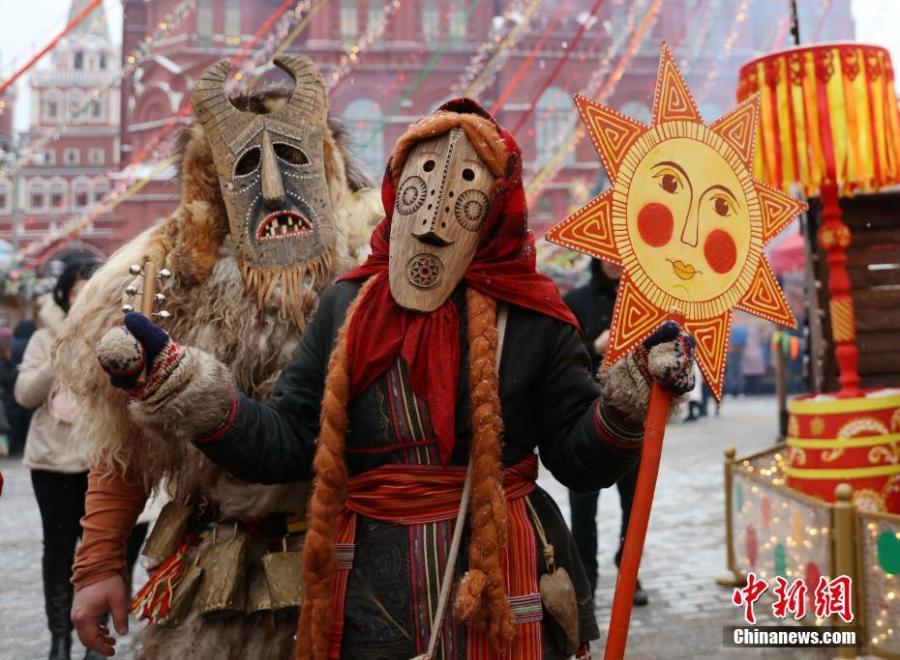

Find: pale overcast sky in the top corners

[0,0,900,130]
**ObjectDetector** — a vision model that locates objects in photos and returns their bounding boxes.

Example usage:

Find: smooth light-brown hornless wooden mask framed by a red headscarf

[389,128,496,312]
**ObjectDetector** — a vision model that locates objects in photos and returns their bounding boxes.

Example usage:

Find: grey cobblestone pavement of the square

[0,398,832,660]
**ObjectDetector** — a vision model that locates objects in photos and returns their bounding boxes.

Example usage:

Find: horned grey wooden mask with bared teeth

[192,55,334,268]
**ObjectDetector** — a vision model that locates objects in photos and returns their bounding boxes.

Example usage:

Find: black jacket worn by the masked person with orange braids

[197,282,639,492]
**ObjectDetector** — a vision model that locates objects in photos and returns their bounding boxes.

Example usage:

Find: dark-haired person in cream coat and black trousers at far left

[15,262,146,660]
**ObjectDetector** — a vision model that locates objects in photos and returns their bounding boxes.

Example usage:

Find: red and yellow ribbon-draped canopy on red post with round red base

[738,43,900,513]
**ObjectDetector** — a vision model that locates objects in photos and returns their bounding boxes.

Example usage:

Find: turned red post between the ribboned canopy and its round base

[819,182,863,398]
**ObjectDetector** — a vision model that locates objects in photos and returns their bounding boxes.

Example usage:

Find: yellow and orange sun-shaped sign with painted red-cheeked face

[547,43,806,399]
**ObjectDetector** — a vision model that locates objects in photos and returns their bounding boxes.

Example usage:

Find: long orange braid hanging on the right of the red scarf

[454,288,515,651]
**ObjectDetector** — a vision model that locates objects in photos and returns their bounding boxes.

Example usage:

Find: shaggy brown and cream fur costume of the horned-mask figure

[56,64,383,660]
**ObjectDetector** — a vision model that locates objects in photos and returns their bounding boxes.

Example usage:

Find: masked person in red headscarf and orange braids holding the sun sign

[91,99,693,660]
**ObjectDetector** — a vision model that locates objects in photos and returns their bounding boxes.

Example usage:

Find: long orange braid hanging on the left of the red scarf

[294,278,375,660]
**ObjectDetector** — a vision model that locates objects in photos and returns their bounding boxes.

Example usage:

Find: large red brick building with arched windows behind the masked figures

[0,0,853,258]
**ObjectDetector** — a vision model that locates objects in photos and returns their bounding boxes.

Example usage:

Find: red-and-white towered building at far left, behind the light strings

[0,0,120,254]
